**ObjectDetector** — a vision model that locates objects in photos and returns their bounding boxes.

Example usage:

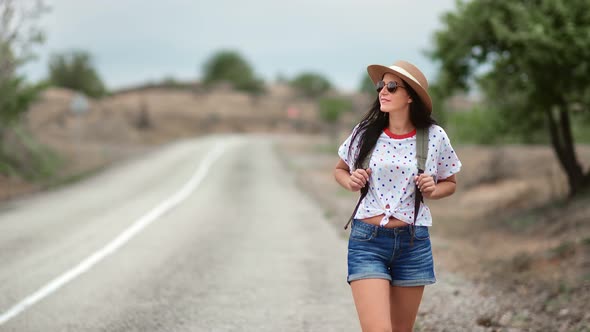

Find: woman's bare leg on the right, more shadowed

[389,286,424,332]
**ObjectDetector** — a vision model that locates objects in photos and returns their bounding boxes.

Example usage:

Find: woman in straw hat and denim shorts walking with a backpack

[334,61,461,332]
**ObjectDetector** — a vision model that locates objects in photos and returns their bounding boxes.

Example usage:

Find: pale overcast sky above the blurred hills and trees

[26,0,455,90]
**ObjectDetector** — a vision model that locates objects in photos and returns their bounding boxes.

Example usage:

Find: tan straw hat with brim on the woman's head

[367,60,432,112]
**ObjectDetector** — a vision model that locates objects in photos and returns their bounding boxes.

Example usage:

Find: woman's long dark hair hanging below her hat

[348,81,437,168]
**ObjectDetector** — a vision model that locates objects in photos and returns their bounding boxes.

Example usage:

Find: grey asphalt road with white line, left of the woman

[0,136,359,332]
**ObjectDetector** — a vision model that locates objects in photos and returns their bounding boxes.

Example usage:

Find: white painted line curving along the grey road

[0,140,227,325]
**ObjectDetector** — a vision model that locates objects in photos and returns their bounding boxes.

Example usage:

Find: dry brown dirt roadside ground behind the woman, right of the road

[277,136,590,331]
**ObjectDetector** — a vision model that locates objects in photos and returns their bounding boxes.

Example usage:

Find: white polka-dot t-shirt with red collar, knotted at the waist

[338,125,461,226]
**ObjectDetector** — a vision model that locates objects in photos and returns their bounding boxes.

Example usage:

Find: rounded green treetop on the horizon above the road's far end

[202,50,264,94]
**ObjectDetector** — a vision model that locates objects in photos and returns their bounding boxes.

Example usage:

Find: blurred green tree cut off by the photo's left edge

[0,0,53,177]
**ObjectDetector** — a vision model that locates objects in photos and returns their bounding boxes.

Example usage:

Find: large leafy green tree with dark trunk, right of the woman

[431,0,590,196]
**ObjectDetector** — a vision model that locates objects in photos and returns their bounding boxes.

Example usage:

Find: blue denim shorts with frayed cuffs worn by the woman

[347,219,436,286]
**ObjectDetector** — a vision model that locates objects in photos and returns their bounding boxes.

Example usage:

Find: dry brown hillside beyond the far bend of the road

[0,84,367,201]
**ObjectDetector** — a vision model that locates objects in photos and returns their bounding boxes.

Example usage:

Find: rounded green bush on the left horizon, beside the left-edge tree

[49,50,106,98]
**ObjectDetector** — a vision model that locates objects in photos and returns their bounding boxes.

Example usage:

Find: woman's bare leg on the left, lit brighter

[350,279,391,332]
